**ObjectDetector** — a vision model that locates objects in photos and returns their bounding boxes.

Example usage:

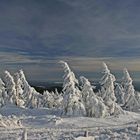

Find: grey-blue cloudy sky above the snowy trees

[0,0,140,81]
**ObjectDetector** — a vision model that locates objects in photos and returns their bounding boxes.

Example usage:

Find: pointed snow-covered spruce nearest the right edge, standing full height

[122,68,140,111]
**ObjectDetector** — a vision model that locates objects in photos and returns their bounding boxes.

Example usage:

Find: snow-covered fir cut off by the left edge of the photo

[0,78,7,107]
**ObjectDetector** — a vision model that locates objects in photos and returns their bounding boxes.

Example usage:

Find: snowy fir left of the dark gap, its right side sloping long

[19,70,43,108]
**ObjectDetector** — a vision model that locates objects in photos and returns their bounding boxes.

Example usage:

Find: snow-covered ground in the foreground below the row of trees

[0,106,140,140]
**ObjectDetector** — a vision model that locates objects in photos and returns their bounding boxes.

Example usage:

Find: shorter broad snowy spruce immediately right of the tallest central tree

[80,76,107,118]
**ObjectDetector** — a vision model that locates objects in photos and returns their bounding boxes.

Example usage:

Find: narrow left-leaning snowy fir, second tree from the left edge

[4,71,17,105]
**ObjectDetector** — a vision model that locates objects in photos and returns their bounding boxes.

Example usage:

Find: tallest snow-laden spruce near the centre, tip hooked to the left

[60,61,86,116]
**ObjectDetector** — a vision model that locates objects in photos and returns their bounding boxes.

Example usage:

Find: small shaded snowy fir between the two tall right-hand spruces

[115,83,124,105]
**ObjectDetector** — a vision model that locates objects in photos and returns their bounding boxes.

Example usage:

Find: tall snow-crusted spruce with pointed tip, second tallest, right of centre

[100,62,124,115]
